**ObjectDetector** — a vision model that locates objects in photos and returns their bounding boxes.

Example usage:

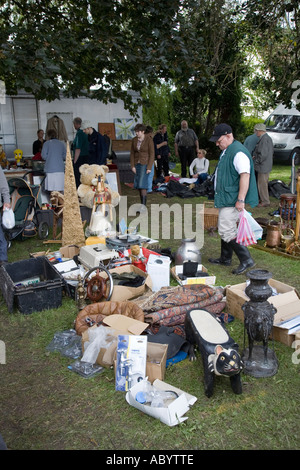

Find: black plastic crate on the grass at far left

[0,256,64,314]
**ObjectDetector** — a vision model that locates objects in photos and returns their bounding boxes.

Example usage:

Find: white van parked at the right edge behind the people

[265,104,300,165]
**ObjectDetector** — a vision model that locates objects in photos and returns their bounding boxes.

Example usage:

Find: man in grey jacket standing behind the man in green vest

[253,123,274,207]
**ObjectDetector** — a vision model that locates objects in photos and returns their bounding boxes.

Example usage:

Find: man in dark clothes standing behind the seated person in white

[174,121,199,178]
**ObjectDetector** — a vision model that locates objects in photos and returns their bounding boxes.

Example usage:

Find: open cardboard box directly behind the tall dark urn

[226,279,300,346]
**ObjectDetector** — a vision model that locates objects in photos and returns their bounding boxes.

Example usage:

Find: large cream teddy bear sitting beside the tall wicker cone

[77,164,120,209]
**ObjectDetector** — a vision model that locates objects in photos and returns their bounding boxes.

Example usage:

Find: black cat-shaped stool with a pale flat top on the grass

[185,310,243,397]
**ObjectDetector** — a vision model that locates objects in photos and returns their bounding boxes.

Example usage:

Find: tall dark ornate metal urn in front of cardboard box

[242,269,278,377]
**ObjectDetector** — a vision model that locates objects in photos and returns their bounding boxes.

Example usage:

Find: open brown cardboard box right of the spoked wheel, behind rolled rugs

[99,264,152,302]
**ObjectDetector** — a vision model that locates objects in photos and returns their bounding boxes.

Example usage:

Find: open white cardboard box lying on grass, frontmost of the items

[126,379,197,426]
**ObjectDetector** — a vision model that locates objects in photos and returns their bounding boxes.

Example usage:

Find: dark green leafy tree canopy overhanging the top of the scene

[0,0,300,120]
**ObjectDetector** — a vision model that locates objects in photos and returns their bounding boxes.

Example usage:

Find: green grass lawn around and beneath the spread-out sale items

[0,165,300,453]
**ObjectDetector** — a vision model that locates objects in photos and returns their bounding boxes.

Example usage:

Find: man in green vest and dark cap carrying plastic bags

[208,124,258,274]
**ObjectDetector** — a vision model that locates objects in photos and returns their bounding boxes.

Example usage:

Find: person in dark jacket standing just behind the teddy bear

[81,121,108,165]
